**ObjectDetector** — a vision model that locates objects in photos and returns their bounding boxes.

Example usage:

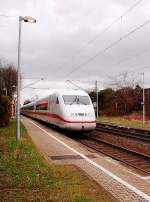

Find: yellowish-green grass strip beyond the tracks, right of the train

[97,116,150,129]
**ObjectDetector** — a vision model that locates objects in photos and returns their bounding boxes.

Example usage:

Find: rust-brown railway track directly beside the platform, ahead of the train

[75,134,150,175]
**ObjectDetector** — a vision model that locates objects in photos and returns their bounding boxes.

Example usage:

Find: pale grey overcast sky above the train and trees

[0,0,150,100]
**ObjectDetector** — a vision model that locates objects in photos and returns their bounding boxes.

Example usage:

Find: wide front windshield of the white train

[63,95,91,105]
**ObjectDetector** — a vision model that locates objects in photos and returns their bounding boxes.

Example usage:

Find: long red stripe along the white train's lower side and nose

[24,110,96,124]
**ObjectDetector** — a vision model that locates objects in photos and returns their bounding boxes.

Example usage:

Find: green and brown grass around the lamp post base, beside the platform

[0,120,115,202]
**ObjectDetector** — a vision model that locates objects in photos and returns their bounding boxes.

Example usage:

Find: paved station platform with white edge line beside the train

[22,118,150,202]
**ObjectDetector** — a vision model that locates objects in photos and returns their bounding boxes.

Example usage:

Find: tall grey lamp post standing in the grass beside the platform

[16,16,36,140]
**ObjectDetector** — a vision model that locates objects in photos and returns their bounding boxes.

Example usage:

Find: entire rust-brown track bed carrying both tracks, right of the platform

[70,124,150,175]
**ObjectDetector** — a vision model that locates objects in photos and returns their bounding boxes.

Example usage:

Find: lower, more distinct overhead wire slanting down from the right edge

[66,20,150,77]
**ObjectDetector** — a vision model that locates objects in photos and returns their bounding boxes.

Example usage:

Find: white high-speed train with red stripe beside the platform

[21,90,96,131]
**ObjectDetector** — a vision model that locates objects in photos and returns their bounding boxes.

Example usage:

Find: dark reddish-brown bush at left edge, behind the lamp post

[0,95,11,127]
